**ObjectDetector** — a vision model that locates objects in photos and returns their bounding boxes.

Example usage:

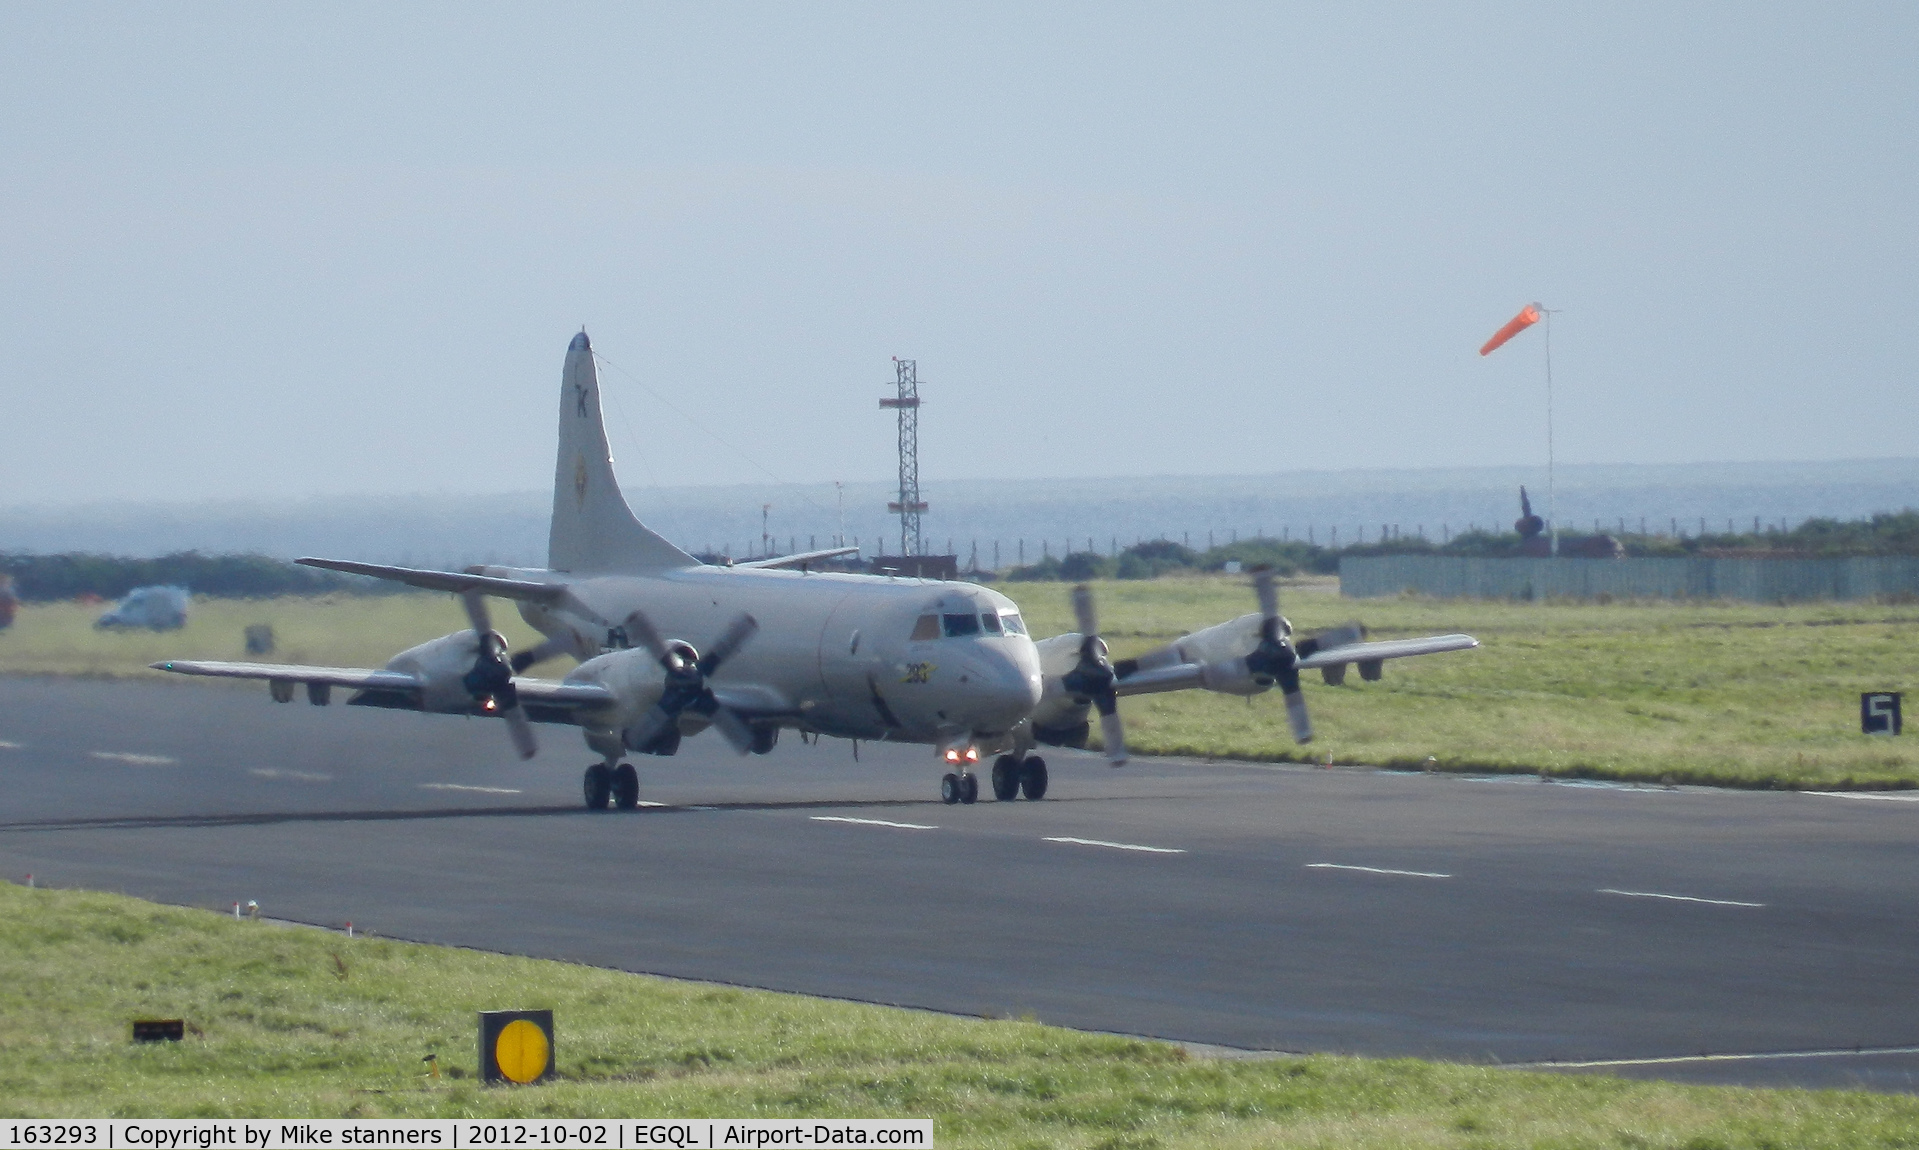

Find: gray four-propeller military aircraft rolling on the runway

[154,332,1480,810]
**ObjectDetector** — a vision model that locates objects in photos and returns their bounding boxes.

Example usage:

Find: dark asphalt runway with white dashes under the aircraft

[0,678,1919,1092]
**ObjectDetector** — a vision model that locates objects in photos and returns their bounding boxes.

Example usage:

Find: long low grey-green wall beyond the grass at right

[1339,555,1919,603]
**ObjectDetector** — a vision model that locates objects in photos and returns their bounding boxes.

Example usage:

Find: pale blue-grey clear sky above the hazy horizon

[0,0,1919,505]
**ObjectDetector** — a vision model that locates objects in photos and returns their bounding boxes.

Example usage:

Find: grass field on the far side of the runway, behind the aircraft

[0,576,1919,789]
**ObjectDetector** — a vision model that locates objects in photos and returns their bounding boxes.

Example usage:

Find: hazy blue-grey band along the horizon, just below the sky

[0,457,1919,566]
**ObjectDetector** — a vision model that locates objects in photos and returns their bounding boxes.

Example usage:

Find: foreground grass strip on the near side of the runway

[0,885,1919,1150]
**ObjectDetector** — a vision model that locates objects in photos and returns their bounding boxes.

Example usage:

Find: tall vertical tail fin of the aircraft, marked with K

[547,332,699,572]
